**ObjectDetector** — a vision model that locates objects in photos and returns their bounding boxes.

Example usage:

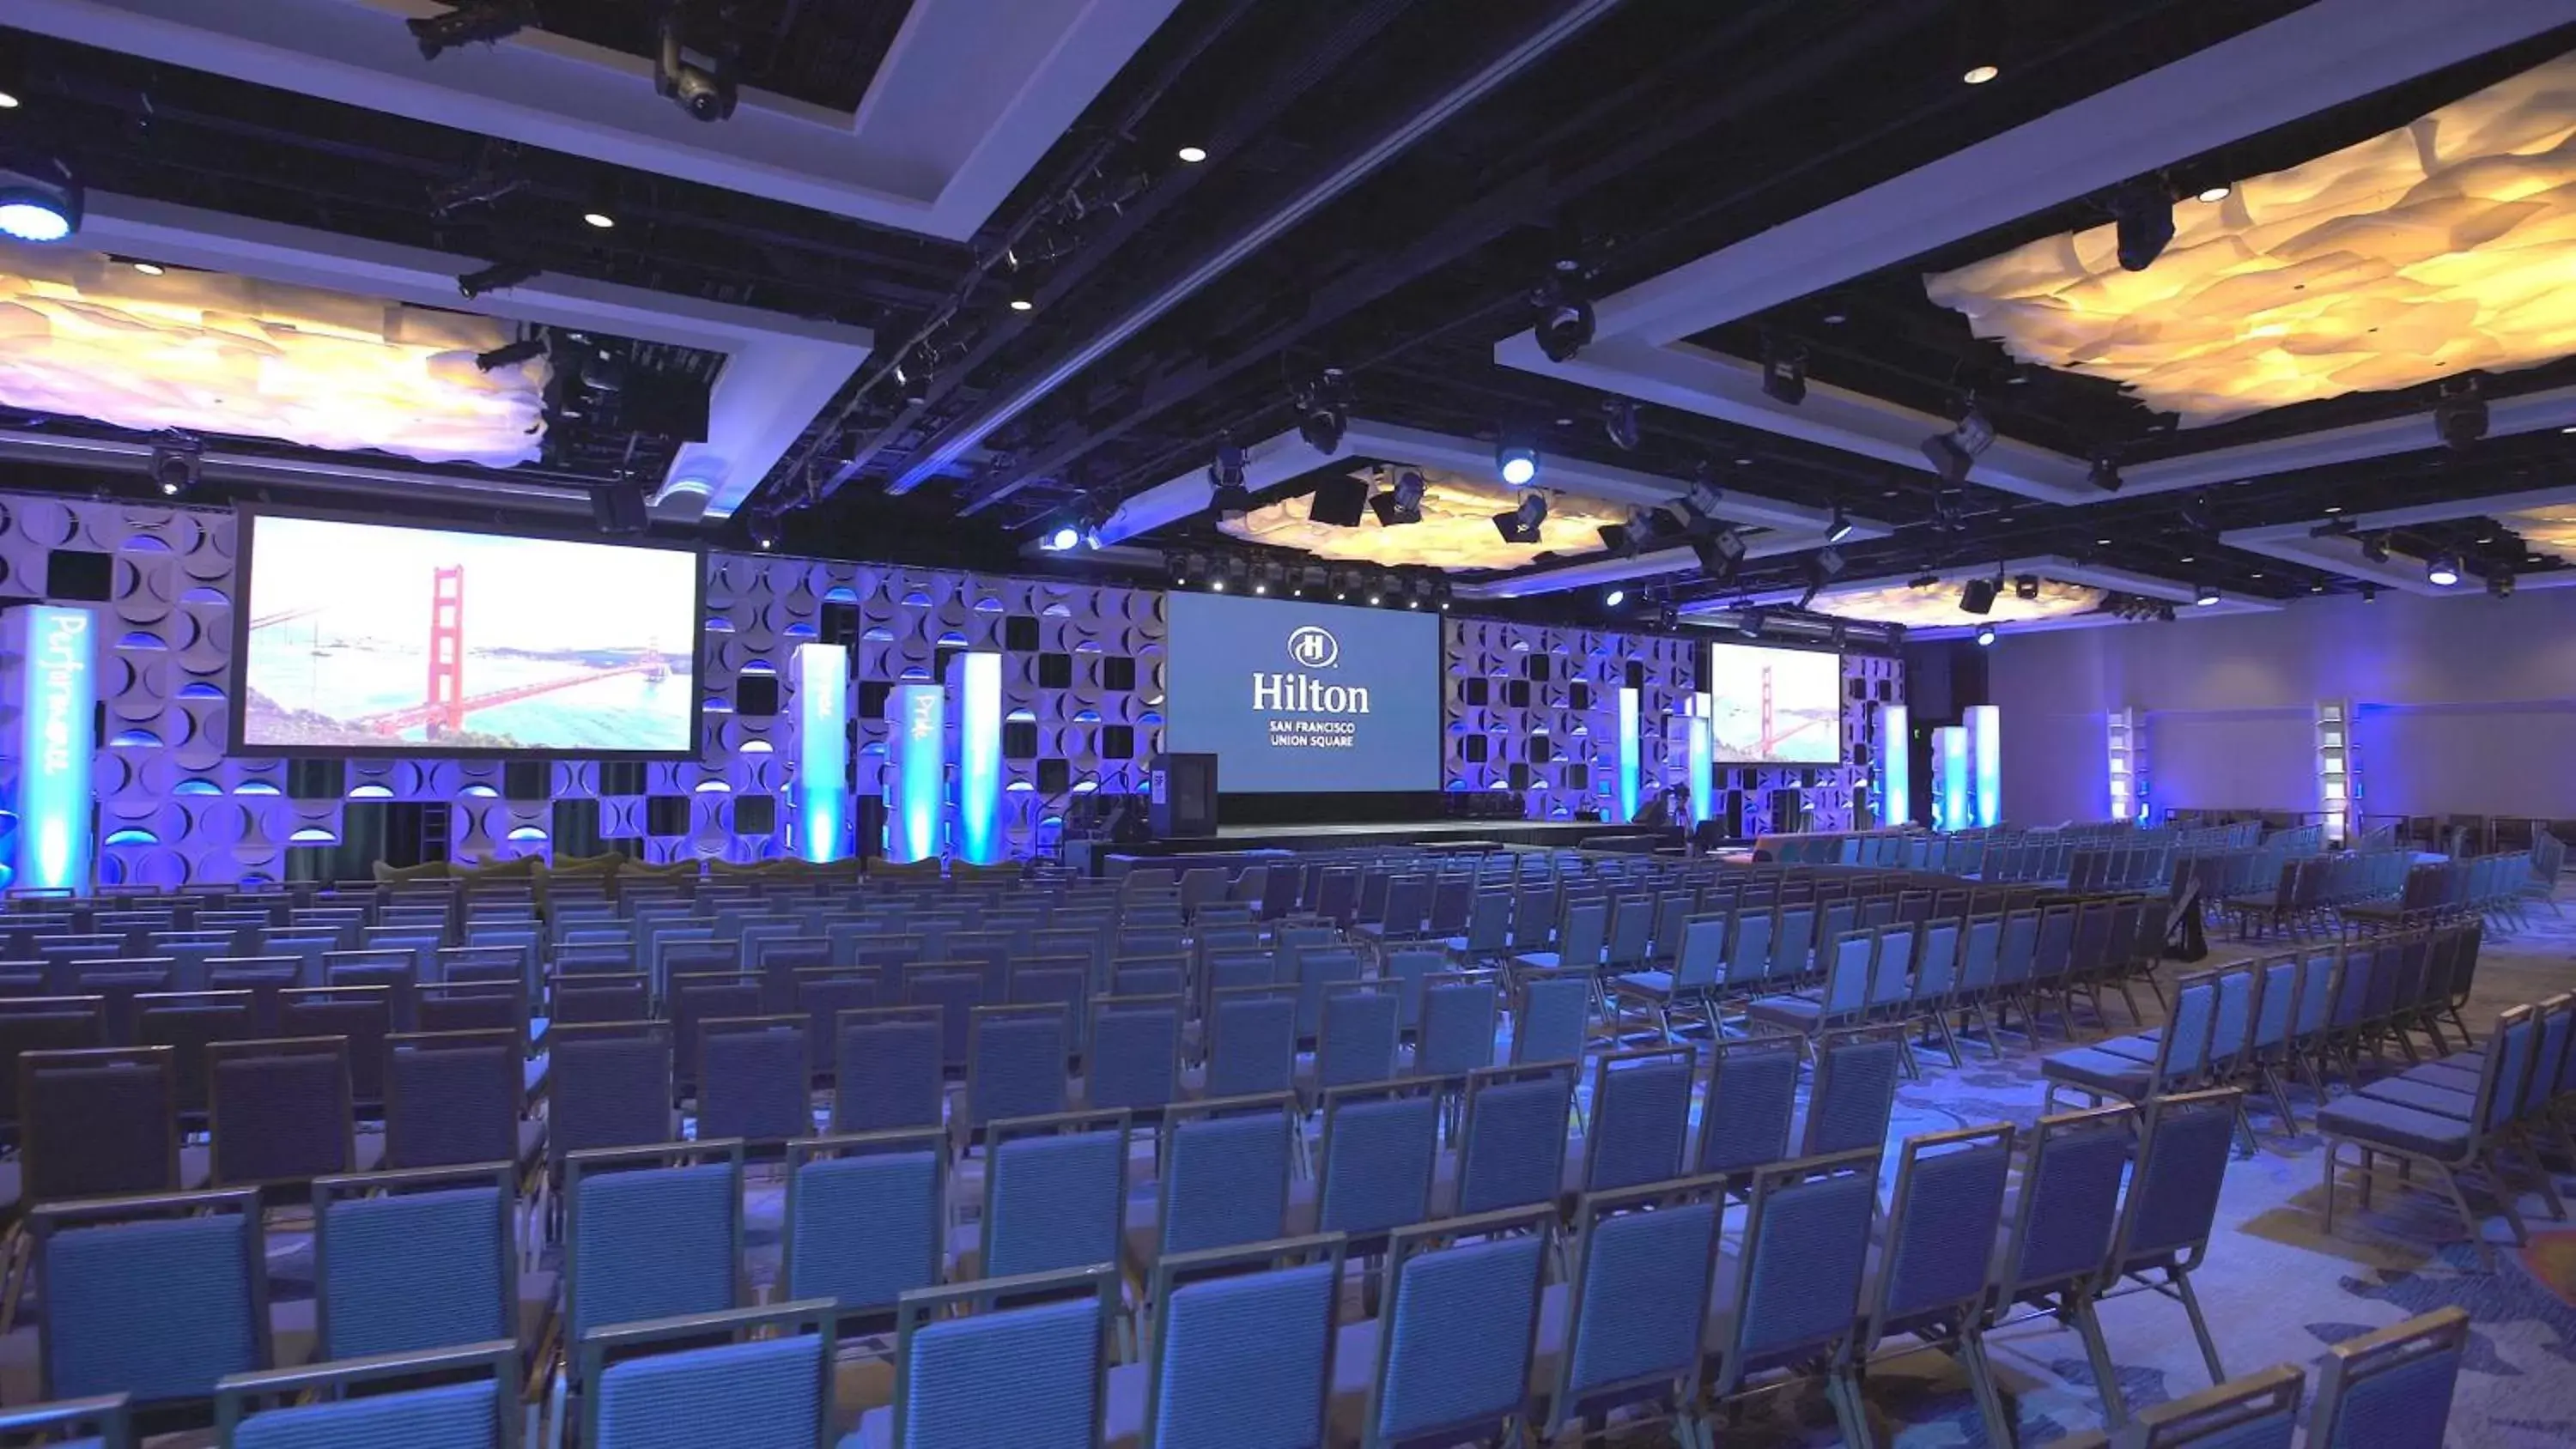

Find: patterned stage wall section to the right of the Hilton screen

[1443,618,1904,836]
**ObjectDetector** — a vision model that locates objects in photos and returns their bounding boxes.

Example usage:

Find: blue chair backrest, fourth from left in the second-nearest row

[778,1127,948,1315]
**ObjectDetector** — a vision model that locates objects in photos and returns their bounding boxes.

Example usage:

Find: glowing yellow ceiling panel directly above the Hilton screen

[1218,469,1628,572]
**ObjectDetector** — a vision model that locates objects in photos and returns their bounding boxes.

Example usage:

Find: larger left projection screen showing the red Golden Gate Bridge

[232,512,703,759]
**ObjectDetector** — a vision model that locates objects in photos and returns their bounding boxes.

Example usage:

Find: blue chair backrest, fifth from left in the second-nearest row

[981,1112,1131,1276]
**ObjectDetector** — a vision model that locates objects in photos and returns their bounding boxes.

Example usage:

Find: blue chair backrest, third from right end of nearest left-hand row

[1860,1122,2012,1354]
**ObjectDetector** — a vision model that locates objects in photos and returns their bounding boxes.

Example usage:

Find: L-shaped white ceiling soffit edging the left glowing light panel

[80,193,876,520]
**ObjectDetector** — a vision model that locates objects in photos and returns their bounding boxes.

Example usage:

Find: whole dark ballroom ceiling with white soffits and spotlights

[0,0,2576,628]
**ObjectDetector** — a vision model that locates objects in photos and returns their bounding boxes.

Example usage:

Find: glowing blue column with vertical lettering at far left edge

[0,605,98,893]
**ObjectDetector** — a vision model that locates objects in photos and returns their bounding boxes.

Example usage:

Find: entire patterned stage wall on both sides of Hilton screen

[0,494,1896,885]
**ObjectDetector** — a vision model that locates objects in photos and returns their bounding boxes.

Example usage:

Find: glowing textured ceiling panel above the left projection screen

[0,245,546,466]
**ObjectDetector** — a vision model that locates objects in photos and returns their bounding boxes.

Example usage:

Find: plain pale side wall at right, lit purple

[1989,590,2576,821]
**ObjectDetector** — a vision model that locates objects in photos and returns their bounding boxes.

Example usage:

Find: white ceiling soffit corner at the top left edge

[8,0,1177,242]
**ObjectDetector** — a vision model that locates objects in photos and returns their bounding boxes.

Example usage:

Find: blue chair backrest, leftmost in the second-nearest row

[28,1189,268,1405]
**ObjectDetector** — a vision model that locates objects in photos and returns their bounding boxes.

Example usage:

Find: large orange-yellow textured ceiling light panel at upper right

[1924,57,2576,427]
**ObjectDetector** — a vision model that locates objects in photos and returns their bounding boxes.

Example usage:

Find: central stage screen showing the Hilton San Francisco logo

[1164,595,1440,792]
